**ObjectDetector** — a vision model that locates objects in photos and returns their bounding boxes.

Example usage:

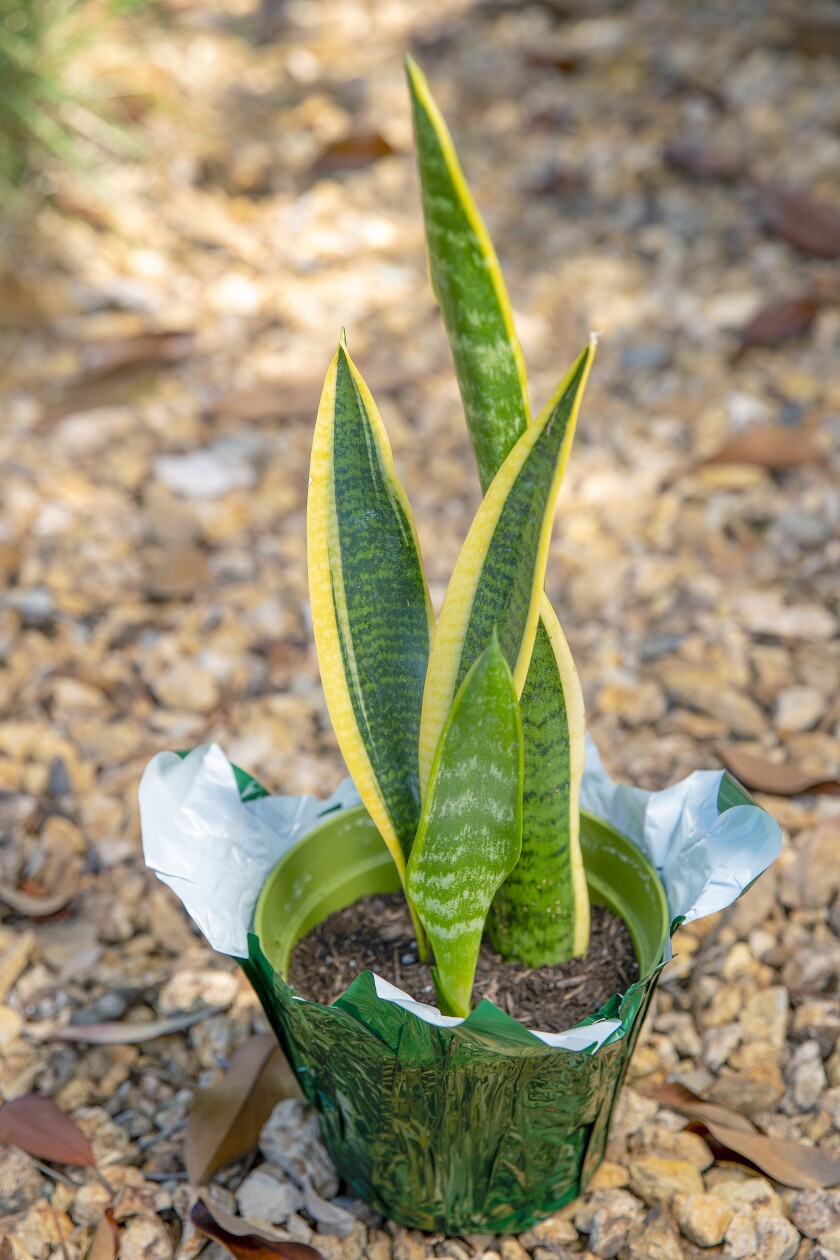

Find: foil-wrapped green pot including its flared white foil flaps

[140,746,781,1235]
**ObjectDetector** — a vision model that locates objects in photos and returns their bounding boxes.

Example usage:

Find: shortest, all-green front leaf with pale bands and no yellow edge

[406,634,523,1016]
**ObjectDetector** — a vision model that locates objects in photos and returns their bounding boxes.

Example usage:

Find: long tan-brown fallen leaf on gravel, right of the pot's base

[652,1082,840,1189]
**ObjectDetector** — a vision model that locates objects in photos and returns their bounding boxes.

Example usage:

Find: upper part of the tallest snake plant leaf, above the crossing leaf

[406,57,529,490]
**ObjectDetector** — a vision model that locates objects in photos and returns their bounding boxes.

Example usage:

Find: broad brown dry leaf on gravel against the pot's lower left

[184,1032,302,1186]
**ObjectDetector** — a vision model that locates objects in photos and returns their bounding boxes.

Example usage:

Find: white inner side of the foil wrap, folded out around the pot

[140,737,782,1050]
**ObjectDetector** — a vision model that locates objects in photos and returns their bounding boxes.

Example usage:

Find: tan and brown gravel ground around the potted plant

[0,0,840,1260]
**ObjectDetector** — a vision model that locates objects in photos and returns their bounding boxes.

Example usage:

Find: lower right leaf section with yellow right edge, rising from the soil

[487,596,589,966]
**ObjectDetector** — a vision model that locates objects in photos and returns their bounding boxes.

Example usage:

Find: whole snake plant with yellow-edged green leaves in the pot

[307,59,594,1016]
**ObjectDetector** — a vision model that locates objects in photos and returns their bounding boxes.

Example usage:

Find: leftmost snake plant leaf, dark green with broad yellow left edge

[312,341,434,882]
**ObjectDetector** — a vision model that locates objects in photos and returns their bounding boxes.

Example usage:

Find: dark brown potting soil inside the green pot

[290,892,639,1032]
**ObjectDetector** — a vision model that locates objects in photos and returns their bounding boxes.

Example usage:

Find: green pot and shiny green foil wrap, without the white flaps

[243,806,669,1235]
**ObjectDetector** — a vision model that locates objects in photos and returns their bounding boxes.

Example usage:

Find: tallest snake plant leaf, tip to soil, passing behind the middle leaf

[407,58,589,966]
